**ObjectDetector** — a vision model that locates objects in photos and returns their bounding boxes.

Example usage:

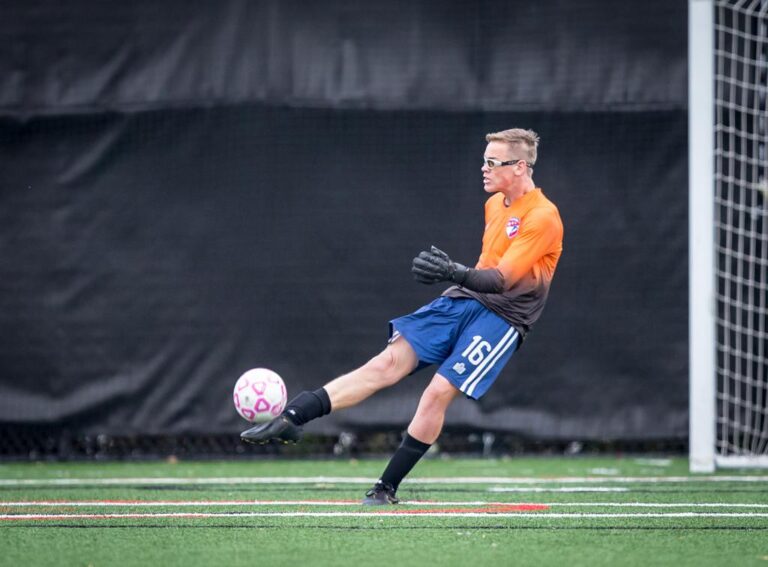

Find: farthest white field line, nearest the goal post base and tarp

[0,475,768,487]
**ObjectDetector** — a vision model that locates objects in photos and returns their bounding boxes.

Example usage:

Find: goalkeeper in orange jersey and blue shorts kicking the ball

[241,128,563,505]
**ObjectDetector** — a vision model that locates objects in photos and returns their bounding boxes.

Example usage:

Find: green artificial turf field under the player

[0,457,768,567]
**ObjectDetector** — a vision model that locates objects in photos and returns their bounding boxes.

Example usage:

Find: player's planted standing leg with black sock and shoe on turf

[363,374,461,505]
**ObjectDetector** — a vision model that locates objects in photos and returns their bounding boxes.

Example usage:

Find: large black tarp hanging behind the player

[0,0,687,439]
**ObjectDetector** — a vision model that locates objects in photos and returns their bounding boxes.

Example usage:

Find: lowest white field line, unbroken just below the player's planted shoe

[0,512,768,520]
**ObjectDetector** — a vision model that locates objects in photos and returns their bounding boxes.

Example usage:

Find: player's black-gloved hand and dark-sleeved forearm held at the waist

[411,246,505,293]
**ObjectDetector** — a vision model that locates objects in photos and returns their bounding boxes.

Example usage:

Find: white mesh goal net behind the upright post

[712,0,768,467]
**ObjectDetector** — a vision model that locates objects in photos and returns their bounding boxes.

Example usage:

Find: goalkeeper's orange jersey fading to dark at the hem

[444,188,563,335]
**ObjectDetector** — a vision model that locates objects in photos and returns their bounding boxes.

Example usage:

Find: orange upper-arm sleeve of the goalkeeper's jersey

[498,207,563,288]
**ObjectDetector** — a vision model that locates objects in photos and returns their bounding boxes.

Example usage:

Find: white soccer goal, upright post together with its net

[688,0,768,472]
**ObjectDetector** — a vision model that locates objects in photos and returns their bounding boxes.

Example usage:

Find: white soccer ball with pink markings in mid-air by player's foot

[232,368,288,423]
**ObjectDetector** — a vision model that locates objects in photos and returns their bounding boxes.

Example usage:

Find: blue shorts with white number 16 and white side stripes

[389,297,520,400]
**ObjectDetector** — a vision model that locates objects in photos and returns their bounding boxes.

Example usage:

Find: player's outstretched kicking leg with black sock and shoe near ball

[240,338,418,443]
